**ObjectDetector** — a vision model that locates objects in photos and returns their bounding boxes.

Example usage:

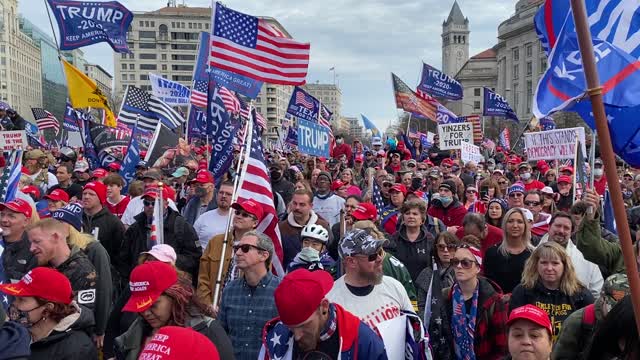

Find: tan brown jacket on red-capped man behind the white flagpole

[196,232,234,304]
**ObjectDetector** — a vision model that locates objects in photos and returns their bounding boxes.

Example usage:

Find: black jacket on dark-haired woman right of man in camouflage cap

[385,225,435,282]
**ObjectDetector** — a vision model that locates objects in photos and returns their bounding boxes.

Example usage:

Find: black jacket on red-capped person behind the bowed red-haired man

[82,207,124,263]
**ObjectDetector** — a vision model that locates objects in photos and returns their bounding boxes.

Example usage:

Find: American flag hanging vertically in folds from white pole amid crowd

[238,121,284,276]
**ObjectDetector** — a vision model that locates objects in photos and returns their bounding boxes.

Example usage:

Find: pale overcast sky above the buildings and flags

[19,0,515,131]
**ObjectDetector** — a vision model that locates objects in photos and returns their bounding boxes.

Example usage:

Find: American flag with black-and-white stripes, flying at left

[118,85,184,131]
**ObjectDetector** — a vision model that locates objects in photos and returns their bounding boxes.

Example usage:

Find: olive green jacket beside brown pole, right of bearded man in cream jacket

[576,213,625,274]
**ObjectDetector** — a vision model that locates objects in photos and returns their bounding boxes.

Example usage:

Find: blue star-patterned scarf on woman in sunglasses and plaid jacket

[451,282,479,360]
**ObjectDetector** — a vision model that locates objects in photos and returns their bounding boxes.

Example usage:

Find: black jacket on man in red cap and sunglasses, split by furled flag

[119,208,202,279]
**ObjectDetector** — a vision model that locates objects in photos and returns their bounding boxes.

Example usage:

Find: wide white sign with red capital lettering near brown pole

[524,128,587,160]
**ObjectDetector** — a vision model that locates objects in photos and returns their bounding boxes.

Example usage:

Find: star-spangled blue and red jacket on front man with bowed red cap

[258,304,387,360]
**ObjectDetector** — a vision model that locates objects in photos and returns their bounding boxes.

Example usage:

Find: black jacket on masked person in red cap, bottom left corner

[29,307,98,360]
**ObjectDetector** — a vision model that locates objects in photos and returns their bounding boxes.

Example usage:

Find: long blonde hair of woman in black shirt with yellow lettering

[522,241,584,296]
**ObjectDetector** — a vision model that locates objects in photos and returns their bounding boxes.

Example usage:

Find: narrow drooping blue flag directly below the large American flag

[206,83,240,179]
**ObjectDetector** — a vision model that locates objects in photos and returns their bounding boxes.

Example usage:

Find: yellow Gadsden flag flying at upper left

[61,59,116,127]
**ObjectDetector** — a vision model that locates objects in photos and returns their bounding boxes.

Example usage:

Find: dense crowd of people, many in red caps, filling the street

[0,131,640,360]
